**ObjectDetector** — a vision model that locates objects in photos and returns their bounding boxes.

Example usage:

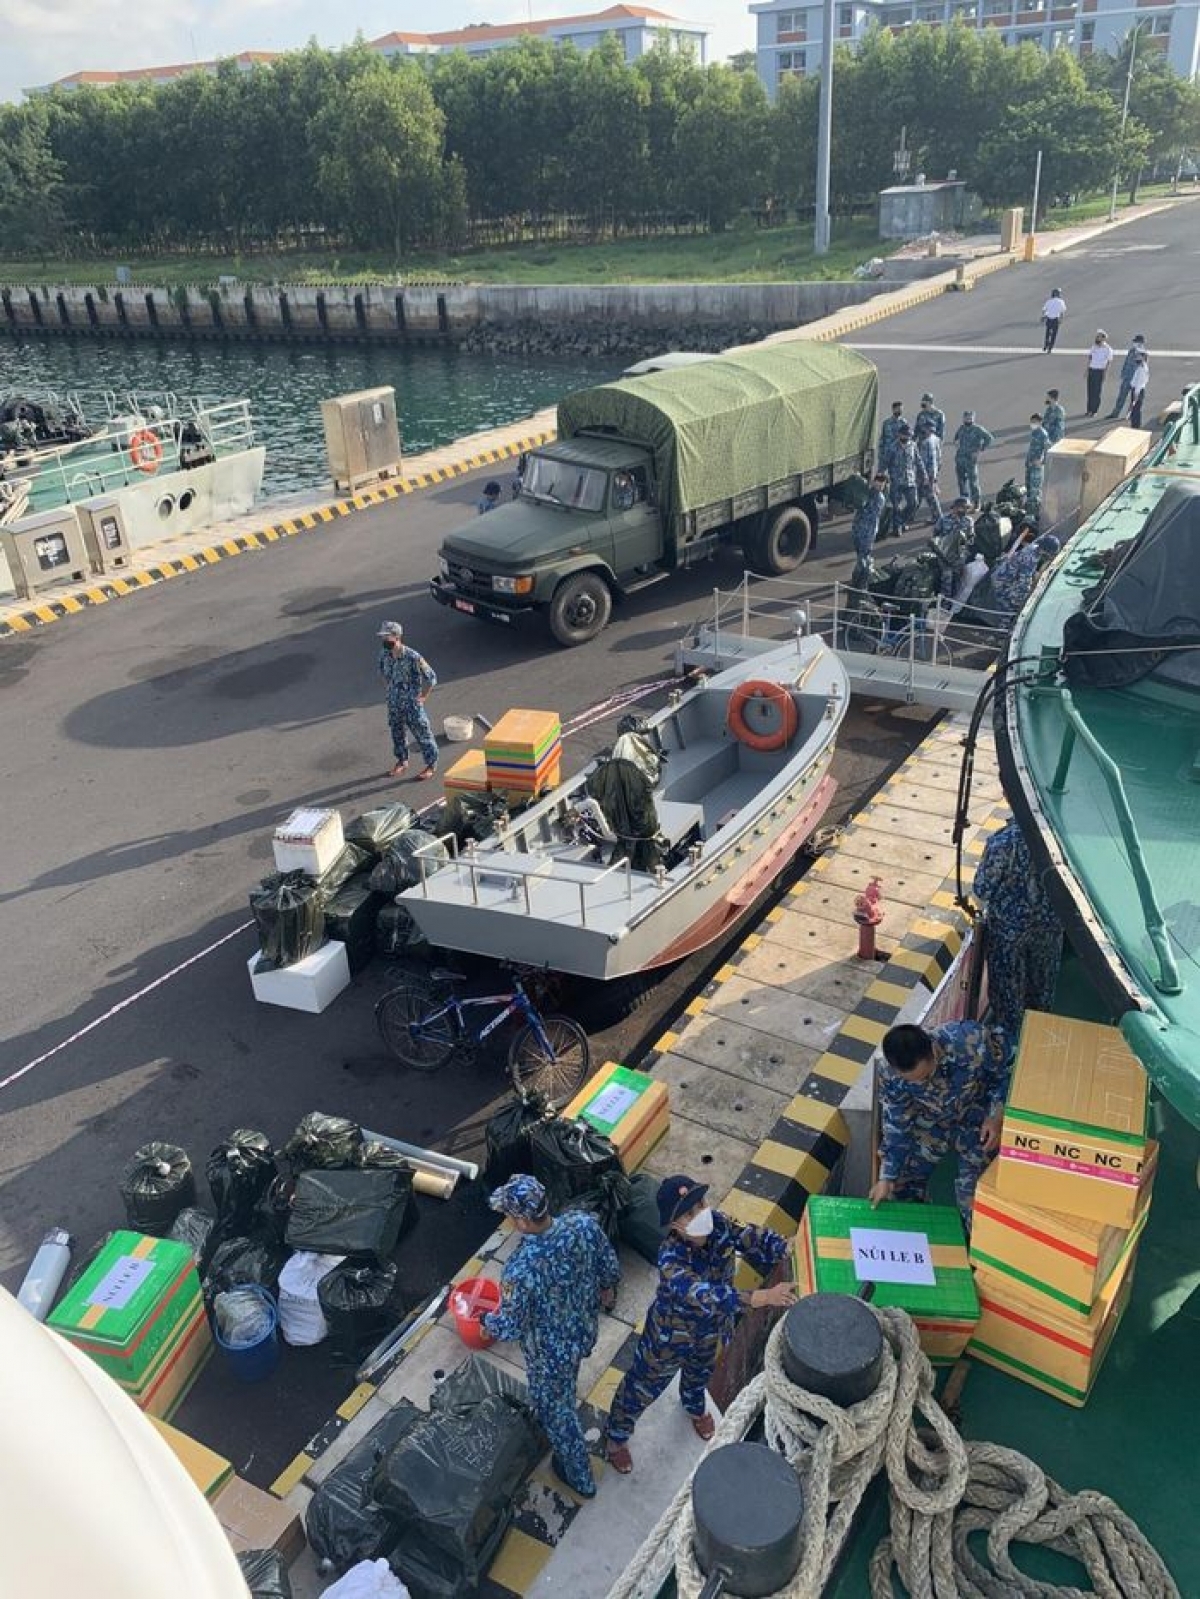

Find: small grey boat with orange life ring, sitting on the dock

[400,636,850,980]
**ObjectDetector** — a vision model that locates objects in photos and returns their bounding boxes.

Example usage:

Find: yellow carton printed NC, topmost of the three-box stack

[995,1011,1154,1228]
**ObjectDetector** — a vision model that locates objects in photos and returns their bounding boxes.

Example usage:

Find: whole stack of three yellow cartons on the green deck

[970,1011,1158,1406]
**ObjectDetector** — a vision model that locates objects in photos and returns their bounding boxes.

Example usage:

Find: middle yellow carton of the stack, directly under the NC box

[971,1140,1158,1316]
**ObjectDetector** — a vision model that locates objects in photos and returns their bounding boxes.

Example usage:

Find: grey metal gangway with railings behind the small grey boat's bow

[675,571,1011,710]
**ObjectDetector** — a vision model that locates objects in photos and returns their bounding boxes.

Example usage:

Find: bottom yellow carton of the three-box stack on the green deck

[966,1249,1138,1409]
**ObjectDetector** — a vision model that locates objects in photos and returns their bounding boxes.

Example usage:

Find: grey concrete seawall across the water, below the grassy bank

[0,275,946,344]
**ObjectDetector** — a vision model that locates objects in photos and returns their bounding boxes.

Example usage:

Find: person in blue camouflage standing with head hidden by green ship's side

[974,822,1062,1038]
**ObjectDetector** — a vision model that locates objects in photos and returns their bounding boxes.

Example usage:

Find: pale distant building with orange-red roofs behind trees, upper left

[26,5,709,94]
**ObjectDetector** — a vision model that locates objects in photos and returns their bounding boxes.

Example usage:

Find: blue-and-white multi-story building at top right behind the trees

[750,0,1200,99]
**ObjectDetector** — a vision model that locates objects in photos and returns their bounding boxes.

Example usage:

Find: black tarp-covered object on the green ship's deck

[1062,483,1200,691]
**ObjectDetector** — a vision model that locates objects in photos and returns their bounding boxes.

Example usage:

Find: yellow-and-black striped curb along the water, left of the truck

[0,432,554,638]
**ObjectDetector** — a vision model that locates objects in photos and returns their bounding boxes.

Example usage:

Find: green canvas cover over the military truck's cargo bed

[558,339,878,515]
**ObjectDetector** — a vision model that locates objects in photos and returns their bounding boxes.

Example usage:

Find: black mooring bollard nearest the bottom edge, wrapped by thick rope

[691,1444,805,1599]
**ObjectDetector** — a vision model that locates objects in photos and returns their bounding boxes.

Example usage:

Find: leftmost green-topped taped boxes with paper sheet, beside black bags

[48,1233,213,1418]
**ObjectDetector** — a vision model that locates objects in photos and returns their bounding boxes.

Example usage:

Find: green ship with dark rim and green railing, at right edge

[995,385,1200,1126]
